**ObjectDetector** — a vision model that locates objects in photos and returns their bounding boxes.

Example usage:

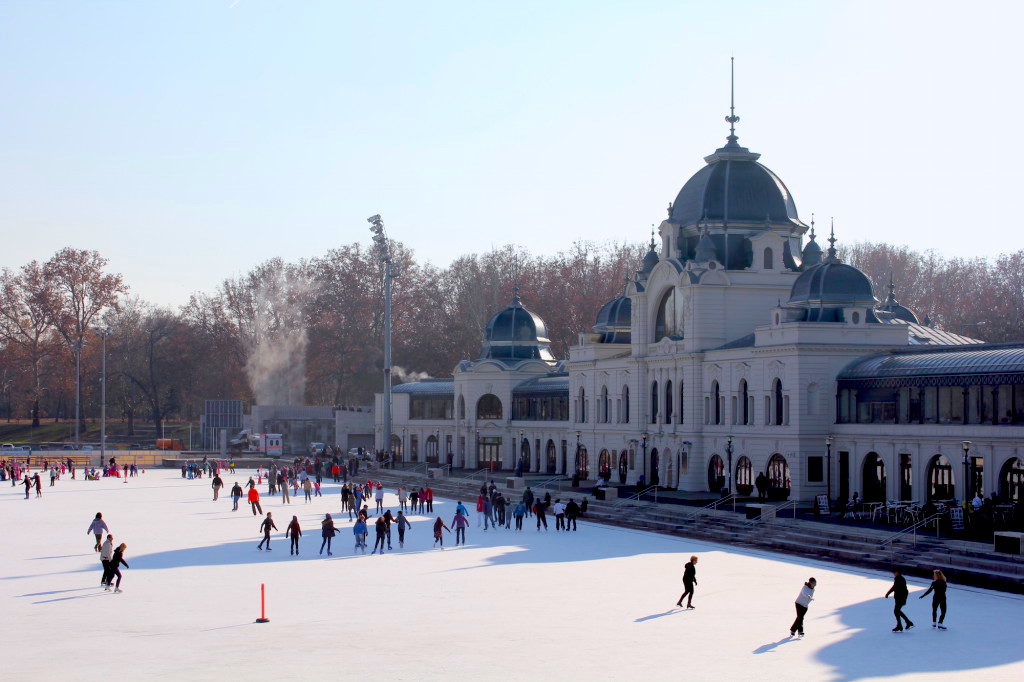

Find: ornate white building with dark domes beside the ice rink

[375,110,1024,502]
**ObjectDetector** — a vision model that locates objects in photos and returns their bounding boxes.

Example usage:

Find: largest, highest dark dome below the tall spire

[670,142,804,227]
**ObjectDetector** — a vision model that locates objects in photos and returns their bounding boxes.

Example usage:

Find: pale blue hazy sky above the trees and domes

[0,0,1024,305]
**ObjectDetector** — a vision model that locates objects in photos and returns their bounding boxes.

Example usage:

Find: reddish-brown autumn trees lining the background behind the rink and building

[0,238,1024,432]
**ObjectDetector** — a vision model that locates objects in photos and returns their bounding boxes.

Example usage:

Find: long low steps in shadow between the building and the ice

[368,469,1024,594]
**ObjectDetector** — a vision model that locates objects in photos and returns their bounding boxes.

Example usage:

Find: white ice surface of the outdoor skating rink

[0,470,1024,681]
